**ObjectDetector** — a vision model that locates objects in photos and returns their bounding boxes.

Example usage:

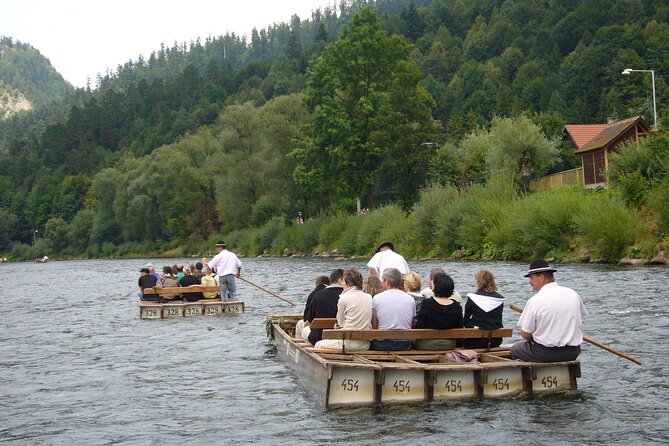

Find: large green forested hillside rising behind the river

[0,0,669,255]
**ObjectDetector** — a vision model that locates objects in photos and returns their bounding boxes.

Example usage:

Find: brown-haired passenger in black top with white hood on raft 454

[464,269,504,348]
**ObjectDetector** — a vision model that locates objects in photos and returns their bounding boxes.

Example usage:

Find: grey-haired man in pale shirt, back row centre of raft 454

[371,268,416,350]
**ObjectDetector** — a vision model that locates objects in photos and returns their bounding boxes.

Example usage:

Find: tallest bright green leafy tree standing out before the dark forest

[293,7,432,213]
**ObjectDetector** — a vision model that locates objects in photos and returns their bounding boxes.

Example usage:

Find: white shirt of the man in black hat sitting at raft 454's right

[518,282,588,347]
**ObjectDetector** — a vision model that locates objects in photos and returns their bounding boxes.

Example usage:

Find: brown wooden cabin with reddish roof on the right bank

[565,116,650,187]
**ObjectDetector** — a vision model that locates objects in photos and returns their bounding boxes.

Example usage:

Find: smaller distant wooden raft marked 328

[139,286,244,319]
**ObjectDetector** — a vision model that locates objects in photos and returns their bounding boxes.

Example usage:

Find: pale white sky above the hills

[0,0,336,87]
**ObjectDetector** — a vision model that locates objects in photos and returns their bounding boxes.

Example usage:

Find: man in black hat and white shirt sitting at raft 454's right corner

[511,259,588,362]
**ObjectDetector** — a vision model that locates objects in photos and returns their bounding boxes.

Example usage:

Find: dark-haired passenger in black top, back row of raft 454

[415,273,462,350]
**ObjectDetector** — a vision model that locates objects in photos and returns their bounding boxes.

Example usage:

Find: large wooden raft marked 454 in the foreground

[268,315,581,409]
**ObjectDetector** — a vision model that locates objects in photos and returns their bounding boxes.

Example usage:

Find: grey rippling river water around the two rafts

[0,258,669,445]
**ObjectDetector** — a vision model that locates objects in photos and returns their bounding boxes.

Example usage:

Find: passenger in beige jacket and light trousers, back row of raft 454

[315,268,372,351]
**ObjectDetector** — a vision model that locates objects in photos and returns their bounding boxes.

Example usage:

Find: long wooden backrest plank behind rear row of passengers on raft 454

[323,328,513,341]
